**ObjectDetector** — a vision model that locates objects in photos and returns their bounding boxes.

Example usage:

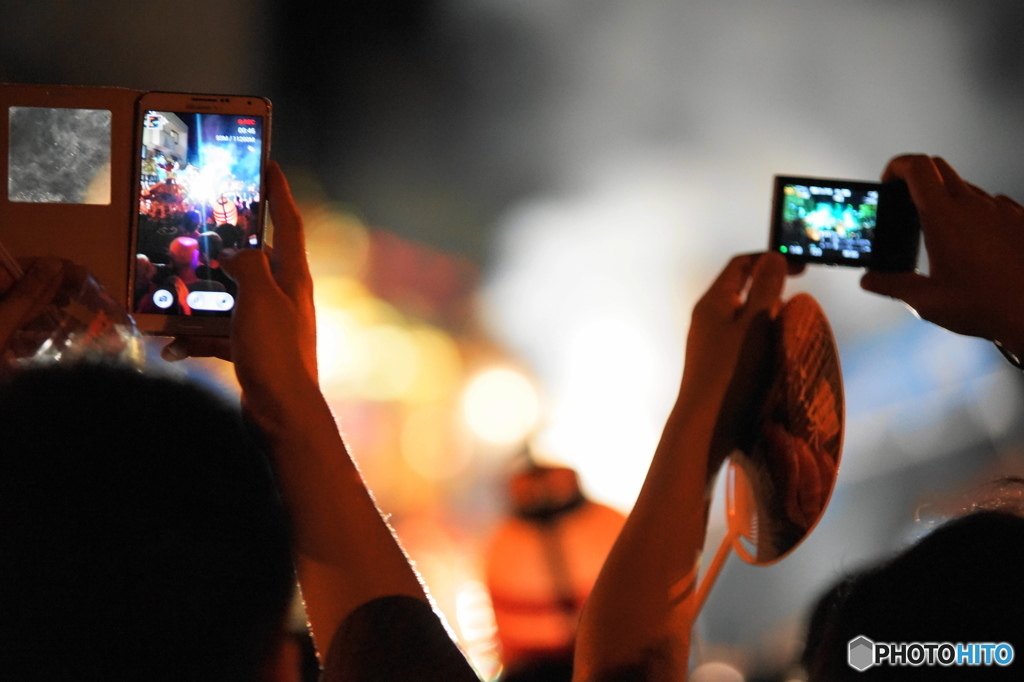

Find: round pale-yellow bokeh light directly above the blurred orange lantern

[462,369,541,444]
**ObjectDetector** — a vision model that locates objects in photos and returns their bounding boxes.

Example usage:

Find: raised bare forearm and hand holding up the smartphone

[164,166,468,670]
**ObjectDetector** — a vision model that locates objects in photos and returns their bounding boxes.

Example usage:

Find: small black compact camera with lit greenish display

[768,175,921,272]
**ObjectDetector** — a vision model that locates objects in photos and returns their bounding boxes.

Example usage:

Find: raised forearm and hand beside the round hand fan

[574,254,786,682]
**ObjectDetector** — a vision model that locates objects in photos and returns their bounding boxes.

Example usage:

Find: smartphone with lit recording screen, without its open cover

[129,92,270,336]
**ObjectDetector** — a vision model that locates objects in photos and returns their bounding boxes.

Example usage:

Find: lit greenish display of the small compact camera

[775,182,879,265]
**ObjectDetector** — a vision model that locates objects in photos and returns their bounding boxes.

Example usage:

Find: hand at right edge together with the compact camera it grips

[769,155,1024,360]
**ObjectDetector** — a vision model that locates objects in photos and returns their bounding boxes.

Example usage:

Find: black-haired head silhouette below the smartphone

[0,366,295,681]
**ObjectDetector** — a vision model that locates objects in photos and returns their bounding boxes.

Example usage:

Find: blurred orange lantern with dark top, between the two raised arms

[486,463,626,671]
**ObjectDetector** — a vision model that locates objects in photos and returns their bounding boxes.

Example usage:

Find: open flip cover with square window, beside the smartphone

[0,83,142,305]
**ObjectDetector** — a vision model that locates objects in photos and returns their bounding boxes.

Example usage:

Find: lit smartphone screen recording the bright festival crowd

[133,111,263,316]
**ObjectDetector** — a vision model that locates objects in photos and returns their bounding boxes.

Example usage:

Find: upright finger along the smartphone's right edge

[267,163,312,300]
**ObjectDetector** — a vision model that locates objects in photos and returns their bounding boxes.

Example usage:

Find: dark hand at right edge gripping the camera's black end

[860,155,1024,357]
